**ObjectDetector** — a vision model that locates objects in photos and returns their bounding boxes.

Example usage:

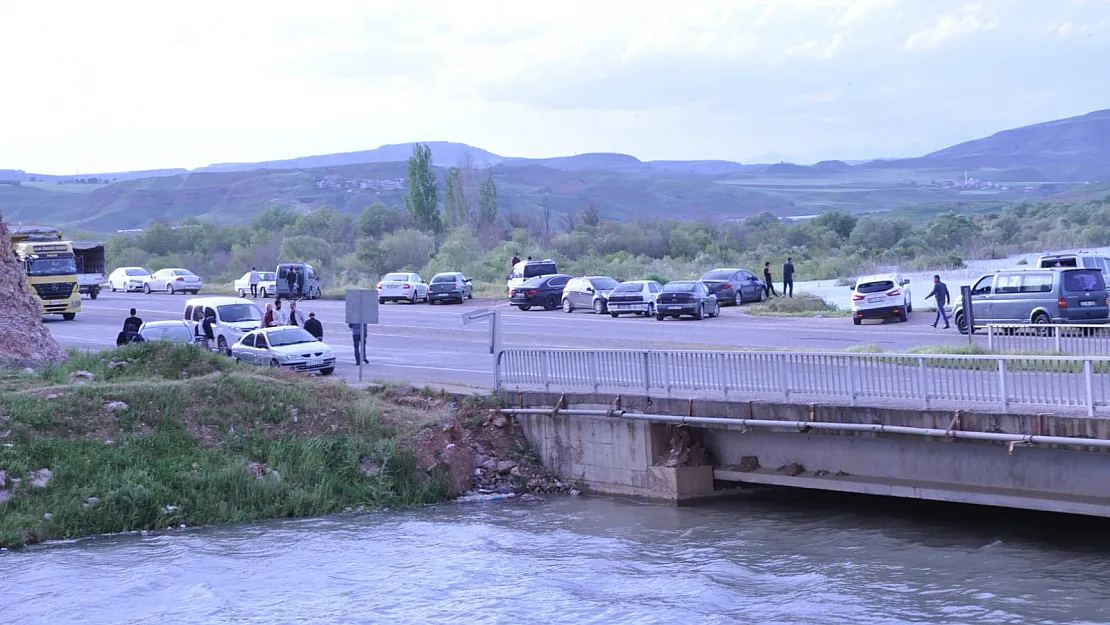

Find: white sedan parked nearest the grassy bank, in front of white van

[231,325,335,375]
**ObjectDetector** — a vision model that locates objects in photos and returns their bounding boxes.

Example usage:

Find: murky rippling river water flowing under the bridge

[0,491,1110,625]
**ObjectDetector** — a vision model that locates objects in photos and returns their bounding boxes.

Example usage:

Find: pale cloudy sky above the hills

[0,0,1110,174]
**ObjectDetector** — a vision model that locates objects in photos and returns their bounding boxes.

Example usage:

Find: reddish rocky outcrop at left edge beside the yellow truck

[0,215,67,366]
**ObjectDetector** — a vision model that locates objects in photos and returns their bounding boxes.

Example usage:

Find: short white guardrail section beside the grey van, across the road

[981,324,1110,356]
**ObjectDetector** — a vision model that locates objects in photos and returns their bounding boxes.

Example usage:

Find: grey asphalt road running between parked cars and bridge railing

[47,292,982,387]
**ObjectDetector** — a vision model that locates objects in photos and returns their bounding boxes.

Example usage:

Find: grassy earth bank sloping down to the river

[0,344,459,547]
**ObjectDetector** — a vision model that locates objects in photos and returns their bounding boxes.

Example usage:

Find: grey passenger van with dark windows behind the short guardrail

[953,269,1110,334]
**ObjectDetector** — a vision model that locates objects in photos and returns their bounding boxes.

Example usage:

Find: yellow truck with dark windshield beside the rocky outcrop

[10,226,81,321]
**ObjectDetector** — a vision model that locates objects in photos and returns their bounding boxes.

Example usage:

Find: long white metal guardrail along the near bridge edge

[494,349,1110,416]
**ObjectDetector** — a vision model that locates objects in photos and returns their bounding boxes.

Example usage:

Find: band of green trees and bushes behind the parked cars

[95,144,1110,292]
